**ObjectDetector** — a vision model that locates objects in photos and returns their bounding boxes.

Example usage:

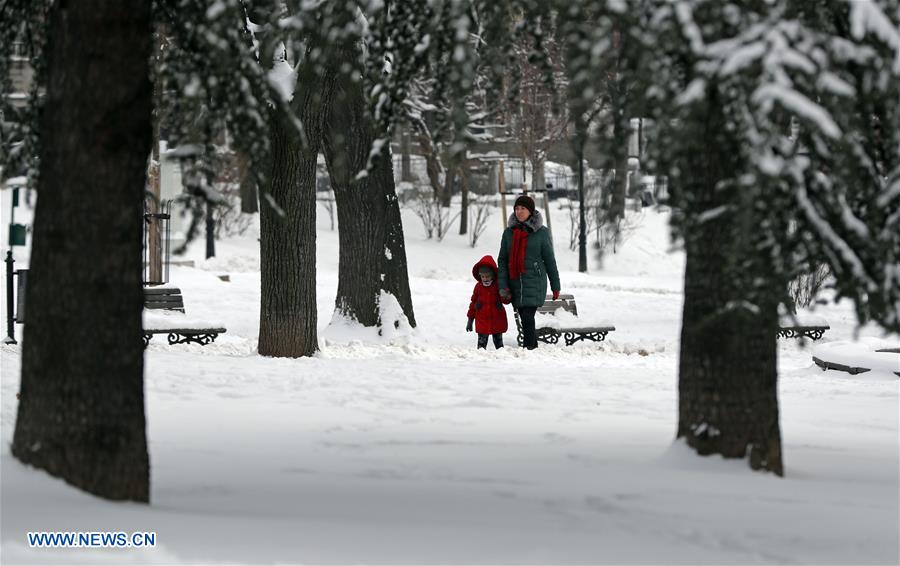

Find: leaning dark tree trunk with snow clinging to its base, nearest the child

[323,47,415,327]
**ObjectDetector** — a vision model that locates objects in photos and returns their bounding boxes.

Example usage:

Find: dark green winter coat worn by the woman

[497,210,559,307]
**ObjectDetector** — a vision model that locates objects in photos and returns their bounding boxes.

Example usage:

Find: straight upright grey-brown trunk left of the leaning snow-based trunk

[259,105,320,358]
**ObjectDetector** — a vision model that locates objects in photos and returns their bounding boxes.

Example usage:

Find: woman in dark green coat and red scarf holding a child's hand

[497,195,559,350]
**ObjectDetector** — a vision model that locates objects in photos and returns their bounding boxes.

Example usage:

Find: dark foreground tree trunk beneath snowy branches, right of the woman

[678,96,783,475]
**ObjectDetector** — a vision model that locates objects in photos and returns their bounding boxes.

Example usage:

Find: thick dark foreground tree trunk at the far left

[12,0,153,502]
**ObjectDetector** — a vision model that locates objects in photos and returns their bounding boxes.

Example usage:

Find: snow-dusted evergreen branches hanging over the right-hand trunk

[629,0,900,331]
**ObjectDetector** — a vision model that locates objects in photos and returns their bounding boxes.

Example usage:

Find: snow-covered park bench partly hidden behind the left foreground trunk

[144,287,225,348]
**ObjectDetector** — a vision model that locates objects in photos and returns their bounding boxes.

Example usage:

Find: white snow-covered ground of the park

[0,195,900,564]
